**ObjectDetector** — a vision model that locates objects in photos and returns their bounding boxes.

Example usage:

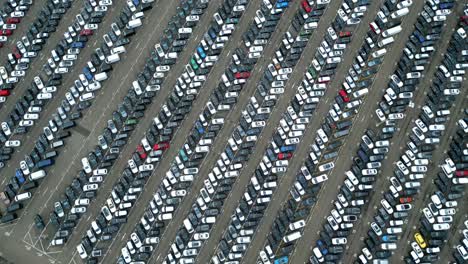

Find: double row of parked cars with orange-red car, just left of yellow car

[352,5,466,263]
